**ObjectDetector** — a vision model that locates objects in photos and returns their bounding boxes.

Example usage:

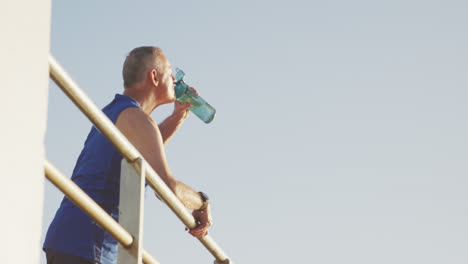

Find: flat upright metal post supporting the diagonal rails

[117,158,145,264]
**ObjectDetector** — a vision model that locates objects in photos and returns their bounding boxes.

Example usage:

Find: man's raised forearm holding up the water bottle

[159,101,190,146]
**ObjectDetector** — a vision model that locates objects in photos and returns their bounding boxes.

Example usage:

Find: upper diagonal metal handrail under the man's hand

[49,54,230,263]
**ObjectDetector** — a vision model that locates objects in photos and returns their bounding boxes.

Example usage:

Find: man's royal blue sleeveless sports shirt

[43,94,141,264]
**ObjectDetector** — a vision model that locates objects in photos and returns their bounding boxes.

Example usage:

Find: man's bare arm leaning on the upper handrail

[116,107,211,237]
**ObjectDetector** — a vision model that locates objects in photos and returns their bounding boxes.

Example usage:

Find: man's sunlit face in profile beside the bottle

[156,55,176,104]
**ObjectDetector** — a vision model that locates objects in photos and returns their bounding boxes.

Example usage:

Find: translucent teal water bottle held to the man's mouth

[174,68,216,124]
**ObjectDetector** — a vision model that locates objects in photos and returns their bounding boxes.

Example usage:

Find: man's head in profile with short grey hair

[122,47,175,104]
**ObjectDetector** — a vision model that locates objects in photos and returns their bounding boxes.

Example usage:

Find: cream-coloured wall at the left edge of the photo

[0,0,51,264]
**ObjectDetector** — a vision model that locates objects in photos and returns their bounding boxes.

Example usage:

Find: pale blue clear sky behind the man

[42,0,468,264]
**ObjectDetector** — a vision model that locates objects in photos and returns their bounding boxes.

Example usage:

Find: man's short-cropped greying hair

[122,46,164,89]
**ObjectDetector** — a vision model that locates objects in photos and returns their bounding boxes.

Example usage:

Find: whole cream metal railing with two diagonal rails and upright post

[45,55,232,264]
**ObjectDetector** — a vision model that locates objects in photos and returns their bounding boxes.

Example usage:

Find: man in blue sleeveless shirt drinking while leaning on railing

[43,47,212,264]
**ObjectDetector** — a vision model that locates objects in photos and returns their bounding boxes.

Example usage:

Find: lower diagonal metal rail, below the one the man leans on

[44,159,159,264]
